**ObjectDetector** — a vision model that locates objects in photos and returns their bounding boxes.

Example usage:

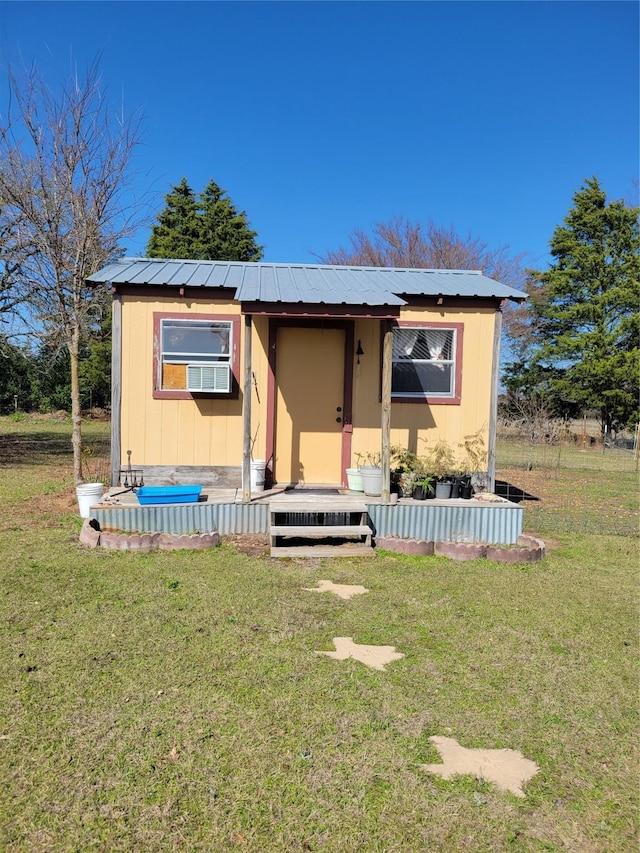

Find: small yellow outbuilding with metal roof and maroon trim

[89,258,526,500]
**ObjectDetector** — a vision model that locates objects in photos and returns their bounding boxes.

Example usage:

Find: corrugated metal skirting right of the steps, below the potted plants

[369,501,524,545]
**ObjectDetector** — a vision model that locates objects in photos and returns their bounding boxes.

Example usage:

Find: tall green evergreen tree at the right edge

[531,177,640,431]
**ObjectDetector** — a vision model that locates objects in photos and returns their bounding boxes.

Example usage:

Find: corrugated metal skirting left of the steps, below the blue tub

[91,503,269,535]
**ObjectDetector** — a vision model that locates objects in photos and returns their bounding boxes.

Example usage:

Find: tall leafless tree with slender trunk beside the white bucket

[0,61,142,483]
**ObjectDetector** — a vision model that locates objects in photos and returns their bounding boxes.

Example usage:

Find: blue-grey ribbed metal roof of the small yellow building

[87,258,527,305]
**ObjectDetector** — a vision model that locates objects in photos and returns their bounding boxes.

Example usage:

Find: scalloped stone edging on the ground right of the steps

[376,536,545,563]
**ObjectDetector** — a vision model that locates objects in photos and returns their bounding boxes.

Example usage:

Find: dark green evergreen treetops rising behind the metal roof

[147,178,263,261]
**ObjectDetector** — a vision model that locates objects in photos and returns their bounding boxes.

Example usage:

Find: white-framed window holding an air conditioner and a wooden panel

[160,318,233,393]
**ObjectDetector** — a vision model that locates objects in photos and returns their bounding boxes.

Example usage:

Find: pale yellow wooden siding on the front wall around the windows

[120,291,496,480]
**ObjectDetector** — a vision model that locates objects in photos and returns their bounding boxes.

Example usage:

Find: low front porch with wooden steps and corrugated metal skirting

[91,487,523,556]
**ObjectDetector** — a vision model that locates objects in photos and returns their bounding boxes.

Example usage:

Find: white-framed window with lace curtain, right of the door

[391,327,458,399]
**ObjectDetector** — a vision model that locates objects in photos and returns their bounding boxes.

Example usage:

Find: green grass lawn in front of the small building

[0,419,639,853]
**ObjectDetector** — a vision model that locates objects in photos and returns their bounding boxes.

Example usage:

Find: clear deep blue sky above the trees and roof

[0,0,639,267]
